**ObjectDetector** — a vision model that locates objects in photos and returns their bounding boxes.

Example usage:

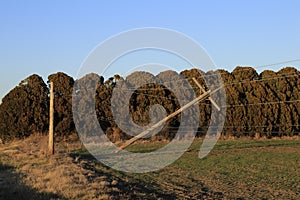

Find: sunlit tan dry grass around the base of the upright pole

[0,136,131,199]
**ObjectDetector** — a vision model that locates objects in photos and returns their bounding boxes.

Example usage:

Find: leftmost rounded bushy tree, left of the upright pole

[0,74,48,142]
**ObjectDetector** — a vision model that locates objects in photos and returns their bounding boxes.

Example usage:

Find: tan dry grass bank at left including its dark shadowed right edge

[0,135,195,199]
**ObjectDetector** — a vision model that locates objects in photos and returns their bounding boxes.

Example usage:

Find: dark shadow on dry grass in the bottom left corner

[0,163,66,200]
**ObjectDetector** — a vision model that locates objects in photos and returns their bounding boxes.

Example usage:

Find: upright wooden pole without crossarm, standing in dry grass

[49,82,54,155]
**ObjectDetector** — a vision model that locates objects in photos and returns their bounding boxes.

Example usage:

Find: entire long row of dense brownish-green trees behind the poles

[0,67,300,142]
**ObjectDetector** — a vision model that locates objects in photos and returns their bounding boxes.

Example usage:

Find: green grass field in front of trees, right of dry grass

[81,140,300,199]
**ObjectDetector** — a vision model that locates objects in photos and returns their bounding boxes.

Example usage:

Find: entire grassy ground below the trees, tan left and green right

[0,135,300,199]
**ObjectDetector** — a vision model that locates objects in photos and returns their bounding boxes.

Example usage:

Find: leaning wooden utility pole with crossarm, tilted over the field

[115,78,224,153]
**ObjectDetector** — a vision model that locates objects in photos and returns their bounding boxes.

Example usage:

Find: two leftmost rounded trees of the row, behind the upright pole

[0,72,75,142]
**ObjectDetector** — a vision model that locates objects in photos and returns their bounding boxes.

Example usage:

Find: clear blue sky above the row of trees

[0,0,300,99]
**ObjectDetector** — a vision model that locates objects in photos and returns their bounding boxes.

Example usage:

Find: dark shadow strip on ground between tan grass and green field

[70,153,224,199]
